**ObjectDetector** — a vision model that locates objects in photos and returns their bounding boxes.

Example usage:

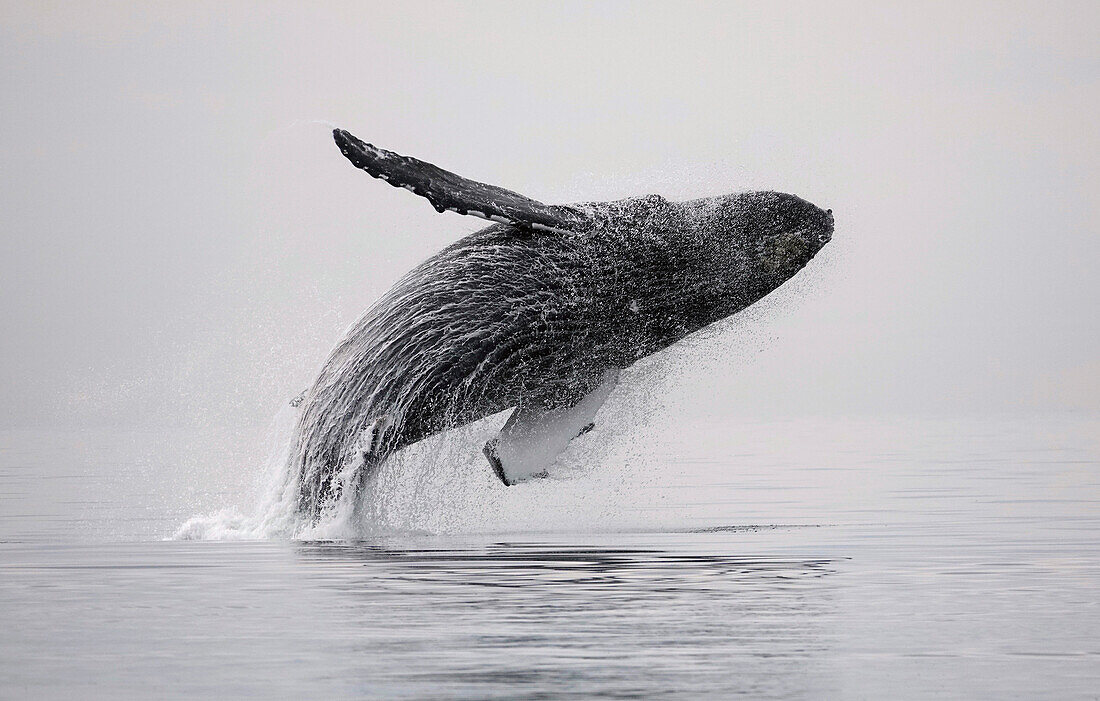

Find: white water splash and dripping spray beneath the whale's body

[172,363,674,540]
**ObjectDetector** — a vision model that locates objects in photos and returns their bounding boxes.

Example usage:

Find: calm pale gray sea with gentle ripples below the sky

[0,416,1100,699]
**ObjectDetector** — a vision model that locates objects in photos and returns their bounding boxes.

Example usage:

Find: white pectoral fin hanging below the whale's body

[484,370,619,486]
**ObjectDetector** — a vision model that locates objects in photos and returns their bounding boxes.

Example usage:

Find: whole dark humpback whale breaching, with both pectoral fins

[288,129,833,518]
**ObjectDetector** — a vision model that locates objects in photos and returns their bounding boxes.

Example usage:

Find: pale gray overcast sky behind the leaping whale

[0,1,1100,426]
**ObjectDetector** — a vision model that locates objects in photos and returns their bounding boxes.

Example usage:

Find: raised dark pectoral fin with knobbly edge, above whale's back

[332,129,591,232]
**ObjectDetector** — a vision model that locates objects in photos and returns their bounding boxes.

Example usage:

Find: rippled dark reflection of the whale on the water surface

[297,538,833,698]
